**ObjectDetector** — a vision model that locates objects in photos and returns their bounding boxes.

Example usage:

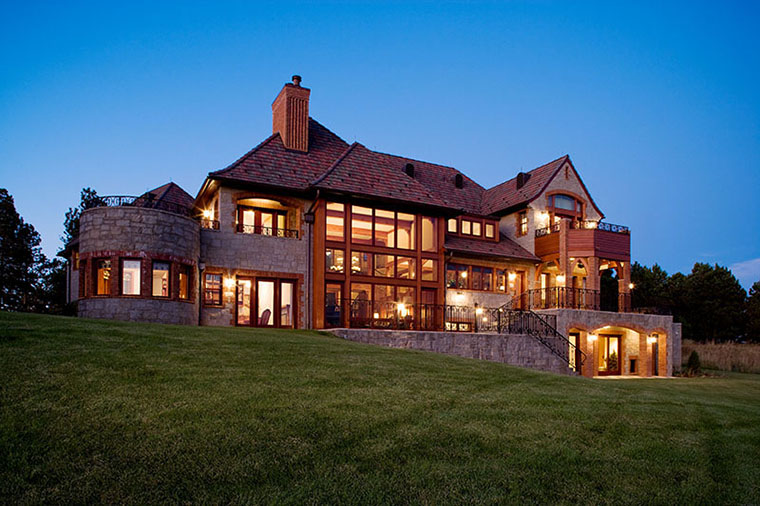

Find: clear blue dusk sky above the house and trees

[0,1,760,288]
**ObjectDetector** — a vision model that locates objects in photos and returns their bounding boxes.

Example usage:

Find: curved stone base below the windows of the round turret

[79,297,198,325]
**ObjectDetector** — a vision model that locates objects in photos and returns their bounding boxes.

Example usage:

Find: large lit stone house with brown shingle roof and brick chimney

[58,76,680,376]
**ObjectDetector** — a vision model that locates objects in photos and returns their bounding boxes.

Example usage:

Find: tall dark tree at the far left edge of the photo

[0,188,44,311]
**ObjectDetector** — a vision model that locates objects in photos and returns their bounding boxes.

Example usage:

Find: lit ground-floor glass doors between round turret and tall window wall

[235,278,298,328]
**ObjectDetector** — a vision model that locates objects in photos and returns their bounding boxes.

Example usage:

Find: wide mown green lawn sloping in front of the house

[0,313,760,504]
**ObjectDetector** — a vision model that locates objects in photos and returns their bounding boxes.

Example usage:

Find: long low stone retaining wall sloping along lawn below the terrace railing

[330,329,573,374]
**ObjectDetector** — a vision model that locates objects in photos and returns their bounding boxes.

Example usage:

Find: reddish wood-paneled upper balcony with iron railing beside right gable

[535,220,631,261]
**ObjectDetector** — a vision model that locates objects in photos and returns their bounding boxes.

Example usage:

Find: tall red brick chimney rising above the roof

[272,76,311,152]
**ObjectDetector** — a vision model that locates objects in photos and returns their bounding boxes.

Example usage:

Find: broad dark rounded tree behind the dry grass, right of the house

[674,263,747,341]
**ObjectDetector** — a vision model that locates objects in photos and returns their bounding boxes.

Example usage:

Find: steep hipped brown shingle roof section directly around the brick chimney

[209,118,348,190]
